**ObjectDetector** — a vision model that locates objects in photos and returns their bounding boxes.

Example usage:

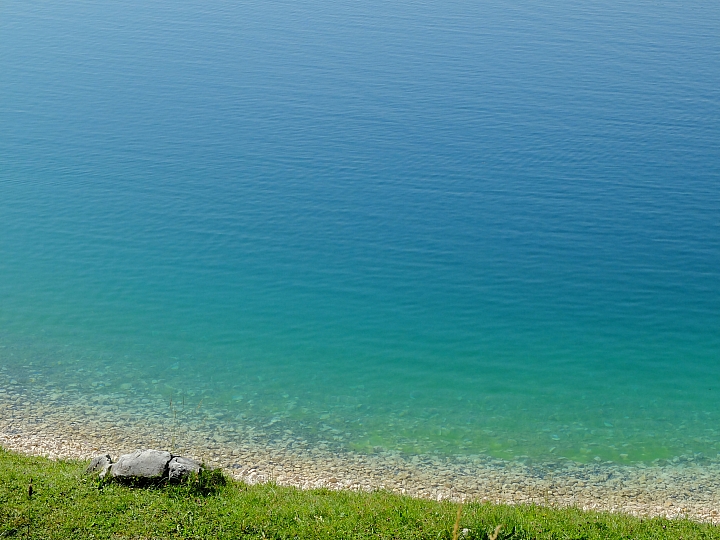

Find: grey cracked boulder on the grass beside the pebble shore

[87,450,201,482]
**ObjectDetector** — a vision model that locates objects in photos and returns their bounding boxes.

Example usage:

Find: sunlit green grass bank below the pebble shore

[0,449,720,540]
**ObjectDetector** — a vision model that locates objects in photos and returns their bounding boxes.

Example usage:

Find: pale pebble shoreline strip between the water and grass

[0,388,720,524]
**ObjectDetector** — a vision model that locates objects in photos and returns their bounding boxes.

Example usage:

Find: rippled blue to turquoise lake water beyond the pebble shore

[0,0,720,463]
